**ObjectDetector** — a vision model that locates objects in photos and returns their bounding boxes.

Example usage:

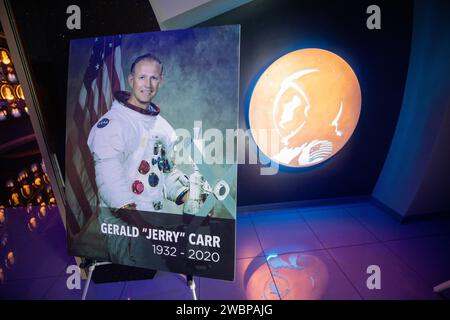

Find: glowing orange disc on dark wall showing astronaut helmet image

[249,49,361,167]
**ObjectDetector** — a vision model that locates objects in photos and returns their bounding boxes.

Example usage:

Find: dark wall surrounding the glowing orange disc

[201,0,413,206]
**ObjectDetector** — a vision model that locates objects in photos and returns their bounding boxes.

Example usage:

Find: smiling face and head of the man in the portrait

[128,60,162,109]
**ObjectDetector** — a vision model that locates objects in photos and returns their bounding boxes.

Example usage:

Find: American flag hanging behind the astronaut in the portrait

[65,35,125,234]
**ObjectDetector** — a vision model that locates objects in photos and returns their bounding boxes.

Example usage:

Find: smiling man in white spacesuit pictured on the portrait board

[88,54,189,265]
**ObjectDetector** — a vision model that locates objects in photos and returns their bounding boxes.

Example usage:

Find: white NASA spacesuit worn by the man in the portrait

[88,91,189,220]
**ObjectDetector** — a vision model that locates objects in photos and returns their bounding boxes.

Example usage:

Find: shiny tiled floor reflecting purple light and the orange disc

[0,202,450,299]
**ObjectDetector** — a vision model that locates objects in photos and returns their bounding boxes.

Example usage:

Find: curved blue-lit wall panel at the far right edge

[373,0,450,216]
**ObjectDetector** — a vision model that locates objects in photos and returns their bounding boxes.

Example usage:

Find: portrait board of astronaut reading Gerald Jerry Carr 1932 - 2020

[65,26,240,280]
